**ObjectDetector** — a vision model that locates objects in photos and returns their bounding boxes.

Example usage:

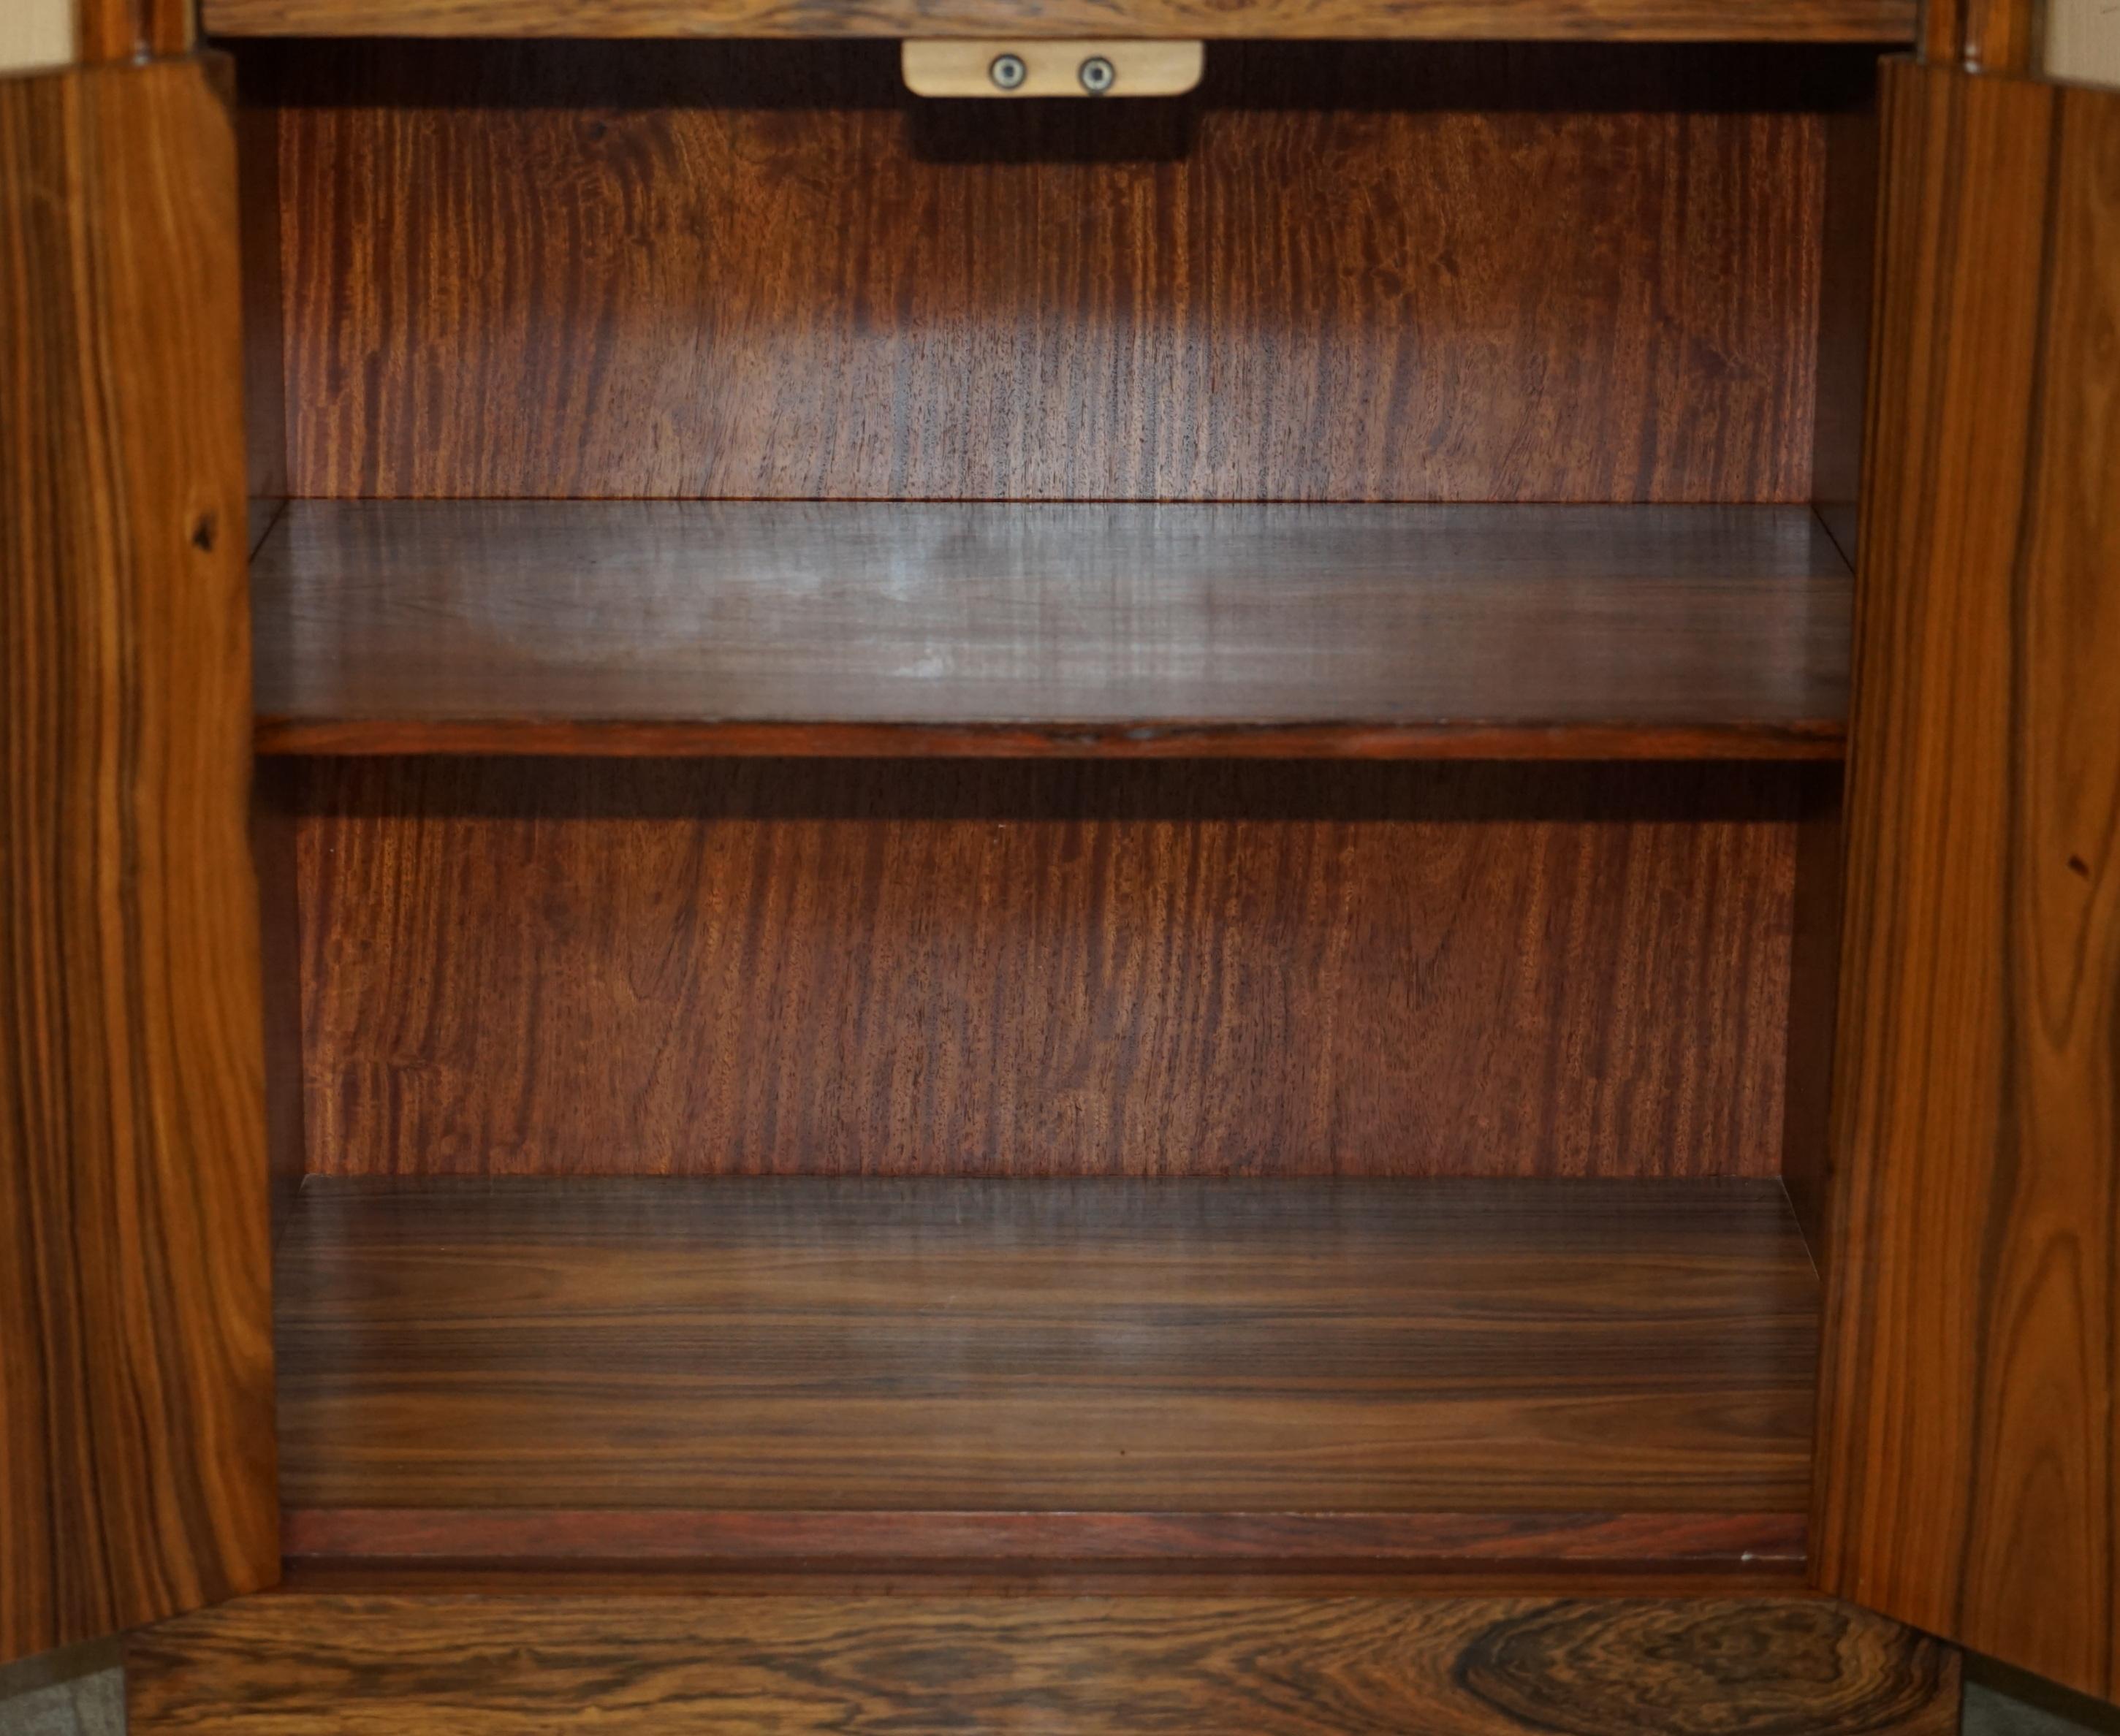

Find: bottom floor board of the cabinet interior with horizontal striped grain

[278,1179,1817,1573]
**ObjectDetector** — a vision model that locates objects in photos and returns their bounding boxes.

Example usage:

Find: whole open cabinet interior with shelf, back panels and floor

[227,30,1906,1585]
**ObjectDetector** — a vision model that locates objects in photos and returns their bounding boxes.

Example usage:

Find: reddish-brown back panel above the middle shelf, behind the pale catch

[244,42,1840,504]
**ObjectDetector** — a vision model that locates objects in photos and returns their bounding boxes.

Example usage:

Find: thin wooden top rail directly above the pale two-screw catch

[202,0,1915,42]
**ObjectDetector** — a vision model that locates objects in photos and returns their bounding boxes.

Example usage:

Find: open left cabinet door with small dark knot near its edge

[0,50,280,1661]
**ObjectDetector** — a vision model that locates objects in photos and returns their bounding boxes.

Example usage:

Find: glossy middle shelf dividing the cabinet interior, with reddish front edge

[254,503,1851,759]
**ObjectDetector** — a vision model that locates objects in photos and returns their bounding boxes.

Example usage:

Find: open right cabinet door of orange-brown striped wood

[1819,66,2120,1696]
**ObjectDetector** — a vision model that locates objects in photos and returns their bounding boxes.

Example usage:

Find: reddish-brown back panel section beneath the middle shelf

[297,759,1798,1176]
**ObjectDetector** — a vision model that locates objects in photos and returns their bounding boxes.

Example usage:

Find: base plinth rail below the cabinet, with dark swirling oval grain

[125,1596,1959,1736]
